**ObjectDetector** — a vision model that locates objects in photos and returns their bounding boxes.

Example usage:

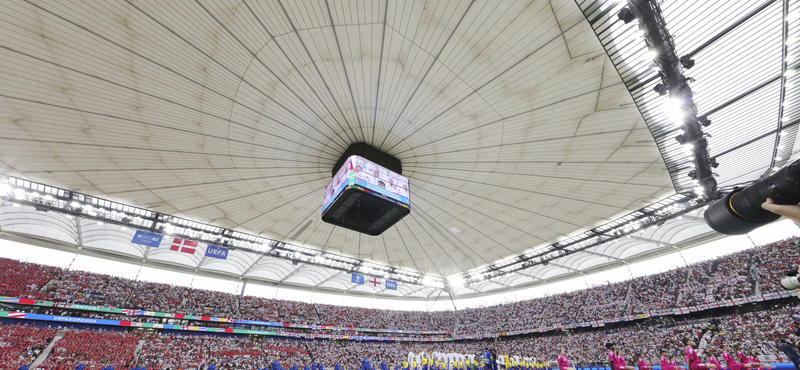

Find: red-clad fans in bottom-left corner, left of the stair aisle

[0,325,56,369]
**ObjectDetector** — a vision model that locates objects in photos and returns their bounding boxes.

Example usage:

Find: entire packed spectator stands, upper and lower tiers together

[0,238,800,369]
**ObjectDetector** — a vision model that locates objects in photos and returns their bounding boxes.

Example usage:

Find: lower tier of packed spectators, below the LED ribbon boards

[0,303,800,370]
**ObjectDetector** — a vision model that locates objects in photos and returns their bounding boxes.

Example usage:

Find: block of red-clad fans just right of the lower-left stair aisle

[39,331,140,370]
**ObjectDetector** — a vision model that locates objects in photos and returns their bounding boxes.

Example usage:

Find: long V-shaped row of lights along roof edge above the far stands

[0,175,705,290]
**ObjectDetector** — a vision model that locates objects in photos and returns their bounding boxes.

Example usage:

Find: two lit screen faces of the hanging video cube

[322,155,409,213]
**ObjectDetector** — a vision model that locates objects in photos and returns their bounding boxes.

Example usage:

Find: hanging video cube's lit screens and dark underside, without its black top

[322,155,411,235]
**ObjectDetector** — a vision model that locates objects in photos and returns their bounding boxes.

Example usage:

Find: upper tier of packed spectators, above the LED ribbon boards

[0,238,800,336]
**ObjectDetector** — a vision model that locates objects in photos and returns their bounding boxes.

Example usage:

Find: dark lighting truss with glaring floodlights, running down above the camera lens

[617,0,721,201]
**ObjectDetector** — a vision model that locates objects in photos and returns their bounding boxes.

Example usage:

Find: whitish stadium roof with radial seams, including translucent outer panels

[0,0,797,298]
